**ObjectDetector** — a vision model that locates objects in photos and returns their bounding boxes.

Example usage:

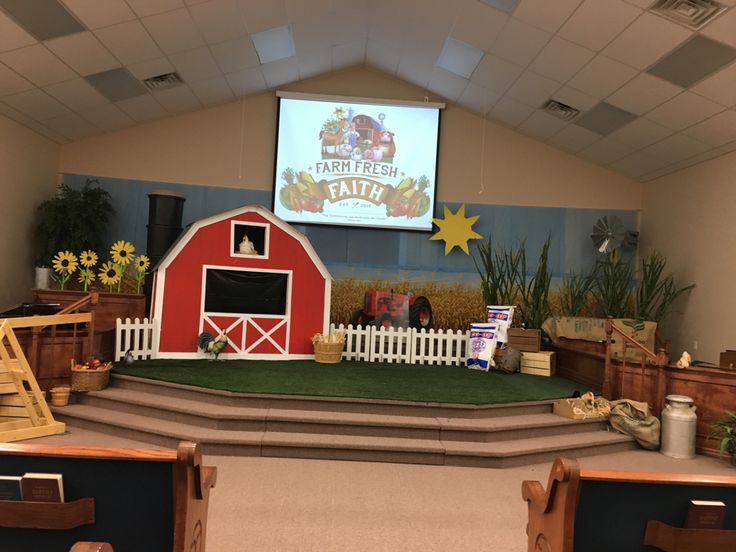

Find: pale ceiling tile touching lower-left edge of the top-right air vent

[603,12,692,69]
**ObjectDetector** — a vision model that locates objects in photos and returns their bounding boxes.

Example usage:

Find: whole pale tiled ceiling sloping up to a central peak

[0,0,736,181]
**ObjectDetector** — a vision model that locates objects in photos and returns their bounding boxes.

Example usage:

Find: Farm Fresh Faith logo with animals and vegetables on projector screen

[278,106,432,219]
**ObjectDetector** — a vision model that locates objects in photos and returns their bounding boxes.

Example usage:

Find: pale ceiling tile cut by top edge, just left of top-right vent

[550,0,640,52]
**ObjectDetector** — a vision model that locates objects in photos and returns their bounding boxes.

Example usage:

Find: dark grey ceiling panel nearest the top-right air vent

[647,34,736,88]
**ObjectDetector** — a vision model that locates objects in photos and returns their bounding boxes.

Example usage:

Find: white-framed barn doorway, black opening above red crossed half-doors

[200,266,292,358]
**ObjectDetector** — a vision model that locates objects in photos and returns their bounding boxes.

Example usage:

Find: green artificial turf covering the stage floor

[113,360,587,404]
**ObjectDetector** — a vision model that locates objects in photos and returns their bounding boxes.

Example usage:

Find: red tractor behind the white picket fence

[350,289,432,329]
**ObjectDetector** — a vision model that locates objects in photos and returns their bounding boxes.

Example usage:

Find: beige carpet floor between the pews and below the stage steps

[28,427,736,552]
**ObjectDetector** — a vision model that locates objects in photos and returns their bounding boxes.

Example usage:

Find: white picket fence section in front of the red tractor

[330,324,468,365]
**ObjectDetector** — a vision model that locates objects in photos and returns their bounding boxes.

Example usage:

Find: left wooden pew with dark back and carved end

[0,441,217,552]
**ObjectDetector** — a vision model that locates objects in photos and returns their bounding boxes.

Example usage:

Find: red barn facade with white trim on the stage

[151,205,332,359]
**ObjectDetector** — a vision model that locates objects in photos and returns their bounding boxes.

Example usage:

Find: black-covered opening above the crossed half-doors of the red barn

[204,268,289,315]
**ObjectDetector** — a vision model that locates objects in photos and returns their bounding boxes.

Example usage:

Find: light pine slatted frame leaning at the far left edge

[0,319,64,442]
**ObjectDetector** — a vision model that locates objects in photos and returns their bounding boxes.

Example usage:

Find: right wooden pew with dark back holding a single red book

[521,459,736,552]
